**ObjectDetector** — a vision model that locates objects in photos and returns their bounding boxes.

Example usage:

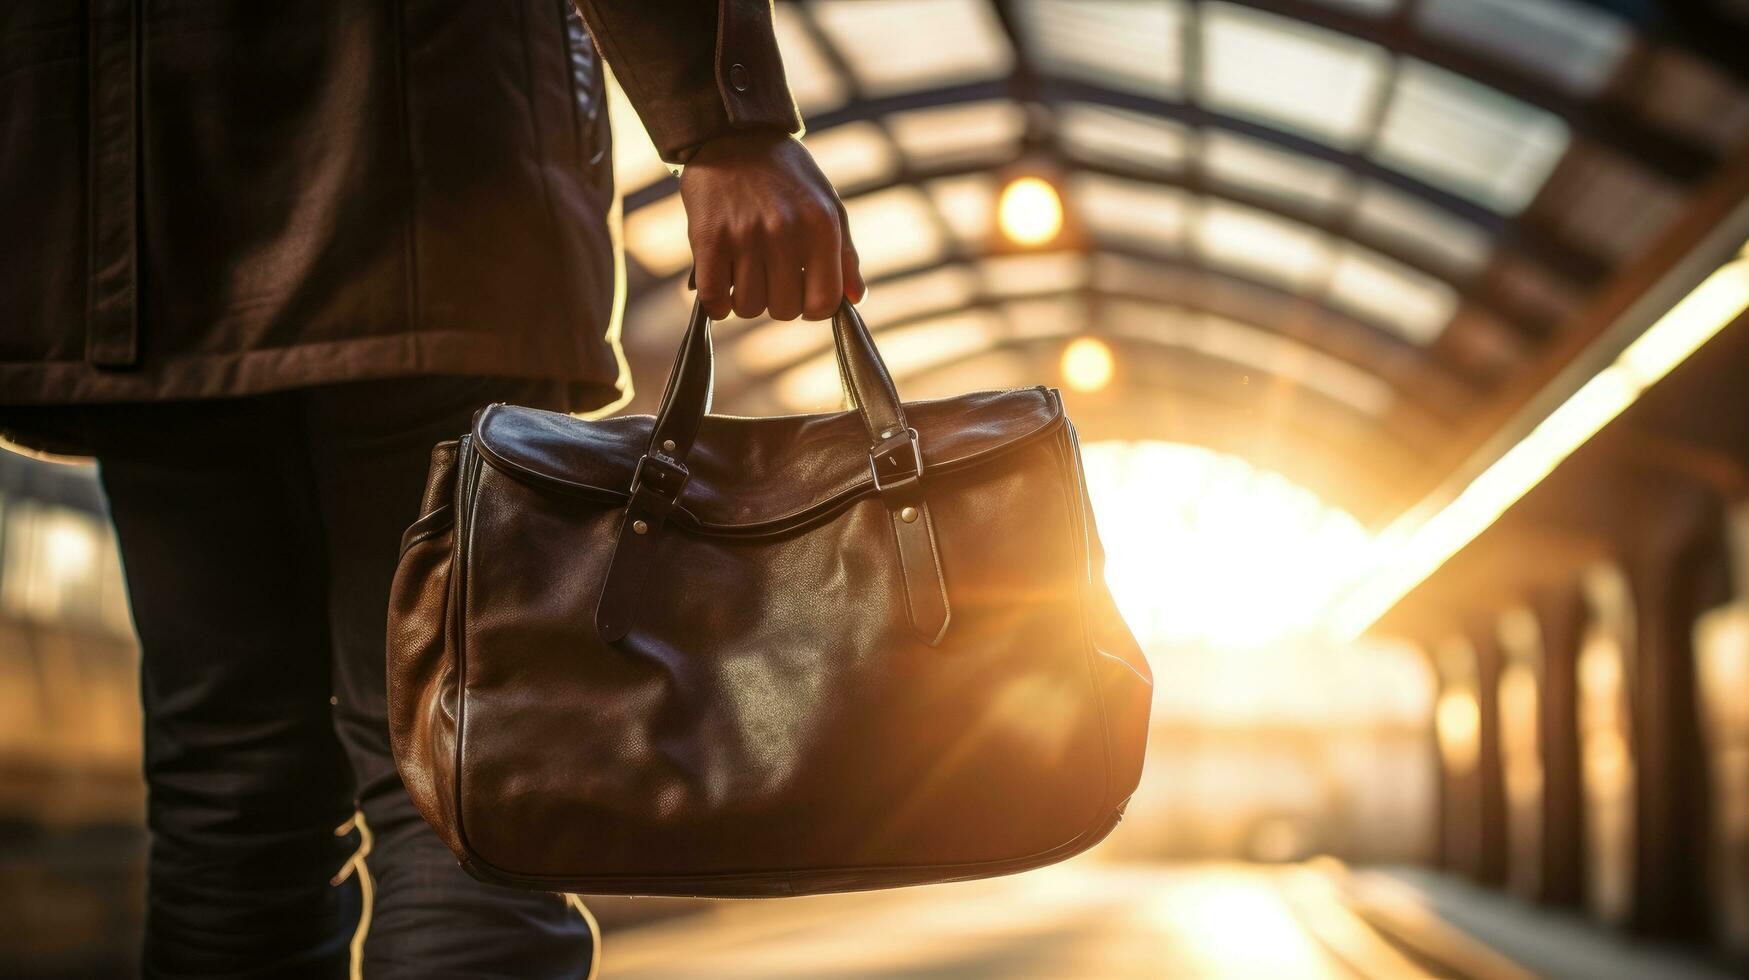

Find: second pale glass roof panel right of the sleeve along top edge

[1020,0,1184,98]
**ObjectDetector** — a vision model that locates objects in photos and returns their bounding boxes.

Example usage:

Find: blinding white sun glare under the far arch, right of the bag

[1081,441,1434,728]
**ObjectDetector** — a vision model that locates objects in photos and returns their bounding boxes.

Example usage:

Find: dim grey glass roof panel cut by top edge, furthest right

[1415,0,1634,95]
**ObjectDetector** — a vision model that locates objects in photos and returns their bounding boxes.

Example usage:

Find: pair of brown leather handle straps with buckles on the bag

[595,299,950,644]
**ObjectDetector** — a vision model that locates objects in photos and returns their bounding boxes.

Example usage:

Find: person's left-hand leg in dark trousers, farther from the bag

[91,397,359,978]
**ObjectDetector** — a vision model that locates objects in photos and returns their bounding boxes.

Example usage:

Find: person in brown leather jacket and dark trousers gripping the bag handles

[0,0,862,978]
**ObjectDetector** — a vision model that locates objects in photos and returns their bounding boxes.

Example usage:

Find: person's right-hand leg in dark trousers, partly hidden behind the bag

[303,378,593,980]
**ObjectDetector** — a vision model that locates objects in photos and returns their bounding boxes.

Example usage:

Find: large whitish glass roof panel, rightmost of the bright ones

[1375,60,1571,215]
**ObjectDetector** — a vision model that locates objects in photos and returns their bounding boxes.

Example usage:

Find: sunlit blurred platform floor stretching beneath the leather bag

[600,861,1733,980]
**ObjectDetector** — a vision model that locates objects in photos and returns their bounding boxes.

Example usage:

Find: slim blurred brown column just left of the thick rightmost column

[1536,583,1586,905]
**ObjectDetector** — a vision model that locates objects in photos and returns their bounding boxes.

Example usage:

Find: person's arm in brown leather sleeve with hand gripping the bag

[577,0,864,320]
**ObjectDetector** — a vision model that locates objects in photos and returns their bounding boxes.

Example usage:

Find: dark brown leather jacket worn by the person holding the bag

[0,0,799,404]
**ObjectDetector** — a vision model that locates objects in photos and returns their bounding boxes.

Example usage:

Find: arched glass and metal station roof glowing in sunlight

[612,0,1749,520]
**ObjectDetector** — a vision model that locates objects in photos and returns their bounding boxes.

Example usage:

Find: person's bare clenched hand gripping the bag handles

[680,130,866,320]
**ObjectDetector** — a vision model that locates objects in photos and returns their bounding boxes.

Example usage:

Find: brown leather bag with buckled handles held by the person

[388,305,1153,896]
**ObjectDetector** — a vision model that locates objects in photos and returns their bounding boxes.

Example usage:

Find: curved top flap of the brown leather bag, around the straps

[474,387,1062,534]
